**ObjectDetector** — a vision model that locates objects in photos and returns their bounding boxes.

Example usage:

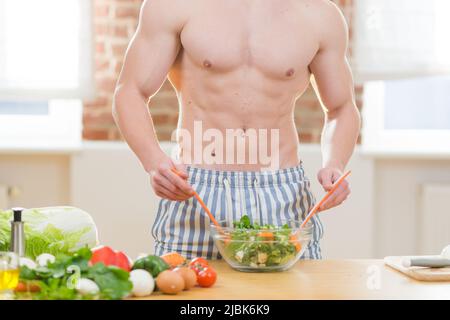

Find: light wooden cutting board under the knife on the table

[384,257,450,281]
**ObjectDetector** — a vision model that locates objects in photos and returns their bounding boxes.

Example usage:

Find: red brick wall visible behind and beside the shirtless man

[83,0,362,143]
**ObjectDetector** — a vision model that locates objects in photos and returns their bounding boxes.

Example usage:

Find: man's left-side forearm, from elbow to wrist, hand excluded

[113,86,164,172]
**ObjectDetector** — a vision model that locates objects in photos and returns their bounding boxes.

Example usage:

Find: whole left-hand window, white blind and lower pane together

[0,0,94,148]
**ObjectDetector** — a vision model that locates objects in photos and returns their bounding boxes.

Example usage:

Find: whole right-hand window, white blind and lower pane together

[353,0,450,155]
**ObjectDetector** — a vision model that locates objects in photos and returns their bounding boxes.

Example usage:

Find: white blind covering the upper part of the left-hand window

[0,0,93,100]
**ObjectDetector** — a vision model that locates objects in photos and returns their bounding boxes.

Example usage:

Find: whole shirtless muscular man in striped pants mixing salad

[114,0,360,258]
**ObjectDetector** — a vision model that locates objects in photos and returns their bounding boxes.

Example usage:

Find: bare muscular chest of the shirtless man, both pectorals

[181,1,319,78]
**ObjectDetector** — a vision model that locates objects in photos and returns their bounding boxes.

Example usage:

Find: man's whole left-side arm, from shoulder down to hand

[113,0,192,200]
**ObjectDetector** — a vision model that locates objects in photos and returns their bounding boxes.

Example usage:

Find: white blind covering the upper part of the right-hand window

[352,0,450,82]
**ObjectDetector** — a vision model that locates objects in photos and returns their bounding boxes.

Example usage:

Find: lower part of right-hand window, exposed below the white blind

[362,77,450,156]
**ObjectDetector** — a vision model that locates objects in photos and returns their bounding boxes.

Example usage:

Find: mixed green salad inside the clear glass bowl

[225,215,301,268]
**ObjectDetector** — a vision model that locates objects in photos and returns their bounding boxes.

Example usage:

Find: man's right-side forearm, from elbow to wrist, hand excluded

[322,102,361,171]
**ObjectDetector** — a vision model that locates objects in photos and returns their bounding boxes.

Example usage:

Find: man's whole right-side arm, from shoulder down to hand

[310,1,361,210]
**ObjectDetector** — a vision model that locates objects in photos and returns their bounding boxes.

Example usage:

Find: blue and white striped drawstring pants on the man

[152,165,323,259]
